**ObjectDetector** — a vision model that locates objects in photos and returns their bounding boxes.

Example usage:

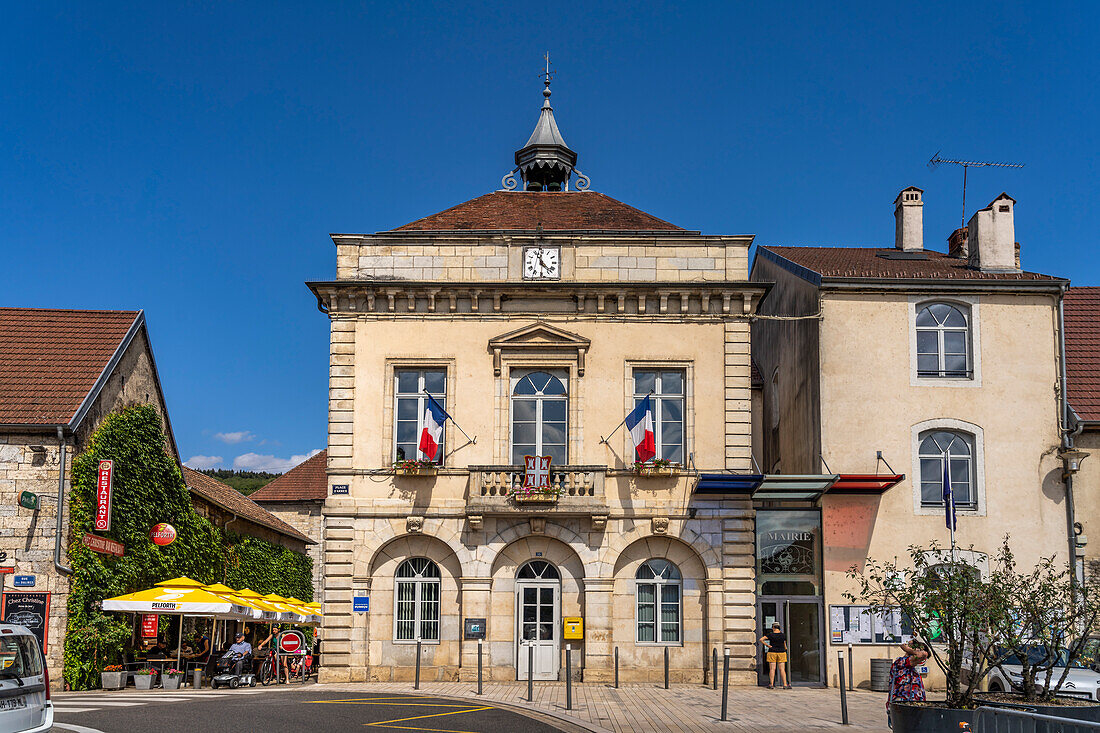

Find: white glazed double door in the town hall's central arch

[516,580,561,680]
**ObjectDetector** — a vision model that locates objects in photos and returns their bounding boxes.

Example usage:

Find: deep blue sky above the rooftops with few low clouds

[0,2,1100,469]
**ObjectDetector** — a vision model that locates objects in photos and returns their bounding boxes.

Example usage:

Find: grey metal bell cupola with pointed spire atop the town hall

[501,53,590,192]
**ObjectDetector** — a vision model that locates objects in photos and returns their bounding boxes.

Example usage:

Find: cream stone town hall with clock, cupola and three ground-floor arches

[309,83,768,682]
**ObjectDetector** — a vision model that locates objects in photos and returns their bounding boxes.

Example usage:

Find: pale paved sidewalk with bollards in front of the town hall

[316,682,889,733]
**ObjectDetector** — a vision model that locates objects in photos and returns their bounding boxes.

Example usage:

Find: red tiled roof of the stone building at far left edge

[0,308,140,425]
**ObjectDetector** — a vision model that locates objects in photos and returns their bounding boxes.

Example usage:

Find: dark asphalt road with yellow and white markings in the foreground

[53,686,572,733]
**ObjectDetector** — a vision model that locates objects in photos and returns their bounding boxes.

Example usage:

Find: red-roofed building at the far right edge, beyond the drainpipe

[1065,287,1100,582]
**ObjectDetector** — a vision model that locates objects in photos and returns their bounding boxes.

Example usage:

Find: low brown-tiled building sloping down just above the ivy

[183,466,317,556]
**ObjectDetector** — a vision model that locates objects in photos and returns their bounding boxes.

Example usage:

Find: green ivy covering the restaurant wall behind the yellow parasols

[65,405,312,690]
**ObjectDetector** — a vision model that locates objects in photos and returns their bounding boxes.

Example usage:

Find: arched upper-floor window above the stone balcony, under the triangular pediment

[512,371,569,466]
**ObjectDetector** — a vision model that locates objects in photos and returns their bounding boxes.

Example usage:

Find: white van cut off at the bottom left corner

[0,624,54,733]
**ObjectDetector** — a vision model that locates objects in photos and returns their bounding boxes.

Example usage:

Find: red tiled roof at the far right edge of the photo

[1065,287,1100,422]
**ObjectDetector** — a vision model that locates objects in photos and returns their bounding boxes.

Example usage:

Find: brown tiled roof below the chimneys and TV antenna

[760,247,1060,281]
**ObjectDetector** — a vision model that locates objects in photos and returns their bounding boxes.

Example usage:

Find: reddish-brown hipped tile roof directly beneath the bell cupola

[393,190,683,231]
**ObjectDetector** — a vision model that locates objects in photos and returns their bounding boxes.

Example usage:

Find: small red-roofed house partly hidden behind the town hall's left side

[249,450,329,601]
